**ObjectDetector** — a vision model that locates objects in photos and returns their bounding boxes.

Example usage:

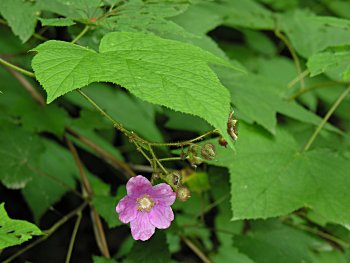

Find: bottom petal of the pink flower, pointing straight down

[130,212,155,241]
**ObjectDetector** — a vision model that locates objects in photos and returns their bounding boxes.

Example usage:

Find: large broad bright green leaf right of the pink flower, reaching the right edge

[224,123,350,224]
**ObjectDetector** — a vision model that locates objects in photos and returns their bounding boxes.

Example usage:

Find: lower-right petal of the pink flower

[149,205,174,229]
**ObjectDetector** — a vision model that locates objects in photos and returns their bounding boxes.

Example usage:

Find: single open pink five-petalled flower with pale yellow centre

[116,175,176,241]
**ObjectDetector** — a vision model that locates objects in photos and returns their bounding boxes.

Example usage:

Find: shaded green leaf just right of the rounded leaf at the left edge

[22,140,78,222]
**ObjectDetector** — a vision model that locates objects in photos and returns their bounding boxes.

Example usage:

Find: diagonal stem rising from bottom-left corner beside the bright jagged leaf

[3,200,89,263]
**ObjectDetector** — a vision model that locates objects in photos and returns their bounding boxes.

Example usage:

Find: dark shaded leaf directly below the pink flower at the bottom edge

[123,234,171,263]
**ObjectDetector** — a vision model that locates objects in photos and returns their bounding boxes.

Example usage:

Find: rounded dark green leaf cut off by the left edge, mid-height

[0,125,43,189]
